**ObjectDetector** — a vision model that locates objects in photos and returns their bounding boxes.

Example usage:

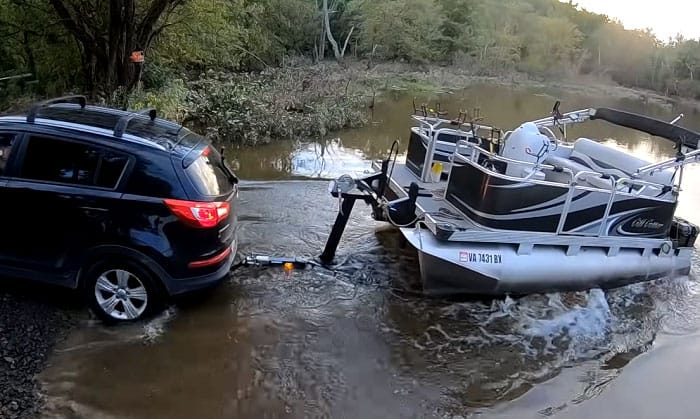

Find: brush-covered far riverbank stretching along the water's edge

[129,61,698,146]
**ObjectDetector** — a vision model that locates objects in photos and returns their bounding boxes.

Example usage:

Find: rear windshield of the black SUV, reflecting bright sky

[185,147,233,196]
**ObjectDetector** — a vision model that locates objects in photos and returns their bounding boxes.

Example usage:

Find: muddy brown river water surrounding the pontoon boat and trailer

[41,86,700,418]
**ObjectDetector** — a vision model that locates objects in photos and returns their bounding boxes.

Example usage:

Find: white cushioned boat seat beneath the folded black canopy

[570,138,675,185]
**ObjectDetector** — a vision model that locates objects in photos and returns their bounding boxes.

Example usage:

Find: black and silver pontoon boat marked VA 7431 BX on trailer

[321,104,700,295]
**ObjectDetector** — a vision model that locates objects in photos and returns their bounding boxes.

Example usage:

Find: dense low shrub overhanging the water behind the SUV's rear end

[188,68,367,144]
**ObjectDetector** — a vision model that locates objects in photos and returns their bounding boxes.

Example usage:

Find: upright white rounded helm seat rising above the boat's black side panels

[502,122,550,178]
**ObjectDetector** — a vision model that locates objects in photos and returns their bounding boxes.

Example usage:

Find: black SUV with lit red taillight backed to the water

[0,96,238,322]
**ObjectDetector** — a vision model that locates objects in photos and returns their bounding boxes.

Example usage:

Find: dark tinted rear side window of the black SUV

[21,136,128,189]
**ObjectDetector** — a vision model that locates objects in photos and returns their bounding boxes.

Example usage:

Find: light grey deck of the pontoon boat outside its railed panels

[373,163,671,255]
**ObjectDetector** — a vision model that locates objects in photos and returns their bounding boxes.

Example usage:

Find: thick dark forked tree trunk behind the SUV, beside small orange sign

[50,0,184,93]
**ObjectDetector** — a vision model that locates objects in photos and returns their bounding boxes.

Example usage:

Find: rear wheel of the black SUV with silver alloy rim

[83,260,163,325]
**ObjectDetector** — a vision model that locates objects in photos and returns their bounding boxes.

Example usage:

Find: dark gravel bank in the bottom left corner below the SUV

[0,279,77,419]
